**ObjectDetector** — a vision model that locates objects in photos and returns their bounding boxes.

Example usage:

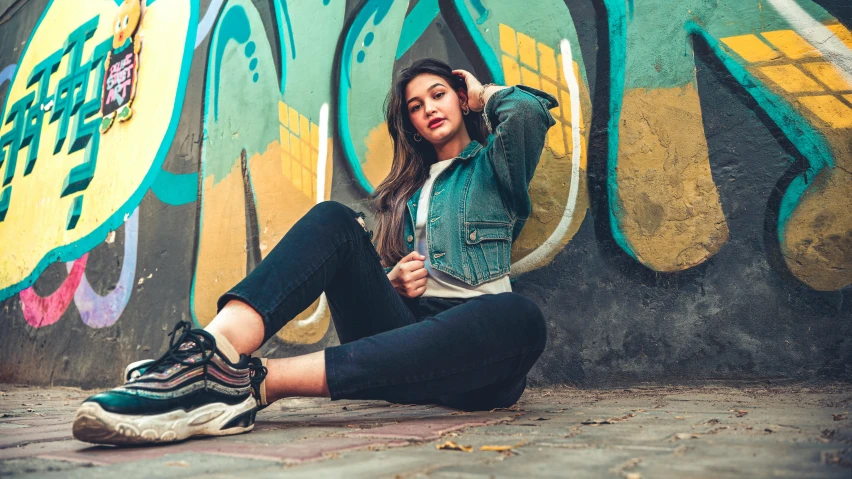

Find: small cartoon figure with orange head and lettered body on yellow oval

[101,0,143,133]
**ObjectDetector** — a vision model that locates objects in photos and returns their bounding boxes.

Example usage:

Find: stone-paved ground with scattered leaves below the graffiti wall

[0,384,852,479]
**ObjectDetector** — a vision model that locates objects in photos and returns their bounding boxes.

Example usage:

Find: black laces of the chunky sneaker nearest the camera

[131,320,218,391]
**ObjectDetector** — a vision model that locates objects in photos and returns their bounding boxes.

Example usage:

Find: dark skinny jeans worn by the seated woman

[217,201,547,410]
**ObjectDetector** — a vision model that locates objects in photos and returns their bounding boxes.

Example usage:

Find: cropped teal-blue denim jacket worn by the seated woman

[385,85,558,286]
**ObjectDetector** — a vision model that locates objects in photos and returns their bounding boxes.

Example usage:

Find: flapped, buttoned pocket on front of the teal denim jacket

[464,221,512,282]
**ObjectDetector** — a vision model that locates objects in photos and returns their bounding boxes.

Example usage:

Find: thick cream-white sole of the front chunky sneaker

[72,396,257,445]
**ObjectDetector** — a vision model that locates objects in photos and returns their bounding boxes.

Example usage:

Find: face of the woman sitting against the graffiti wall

[405,73,467,145]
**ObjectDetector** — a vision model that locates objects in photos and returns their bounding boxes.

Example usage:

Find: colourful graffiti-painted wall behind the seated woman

[0,0,852,386]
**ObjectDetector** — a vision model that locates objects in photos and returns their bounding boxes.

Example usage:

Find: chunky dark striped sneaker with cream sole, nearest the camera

[73,321,257,444]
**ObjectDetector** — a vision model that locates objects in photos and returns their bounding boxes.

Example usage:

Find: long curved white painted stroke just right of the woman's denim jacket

[511,38,582,275]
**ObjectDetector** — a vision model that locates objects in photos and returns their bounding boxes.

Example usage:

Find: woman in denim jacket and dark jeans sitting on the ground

[73,60,557,444]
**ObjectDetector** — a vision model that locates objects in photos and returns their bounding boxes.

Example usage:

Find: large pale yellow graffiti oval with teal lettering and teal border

[0,0,198,300]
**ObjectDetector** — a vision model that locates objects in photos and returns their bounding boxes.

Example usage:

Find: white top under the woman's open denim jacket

[414,158,512,298]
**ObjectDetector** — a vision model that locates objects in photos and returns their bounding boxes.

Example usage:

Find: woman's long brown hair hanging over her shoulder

[370,58,486,266]
